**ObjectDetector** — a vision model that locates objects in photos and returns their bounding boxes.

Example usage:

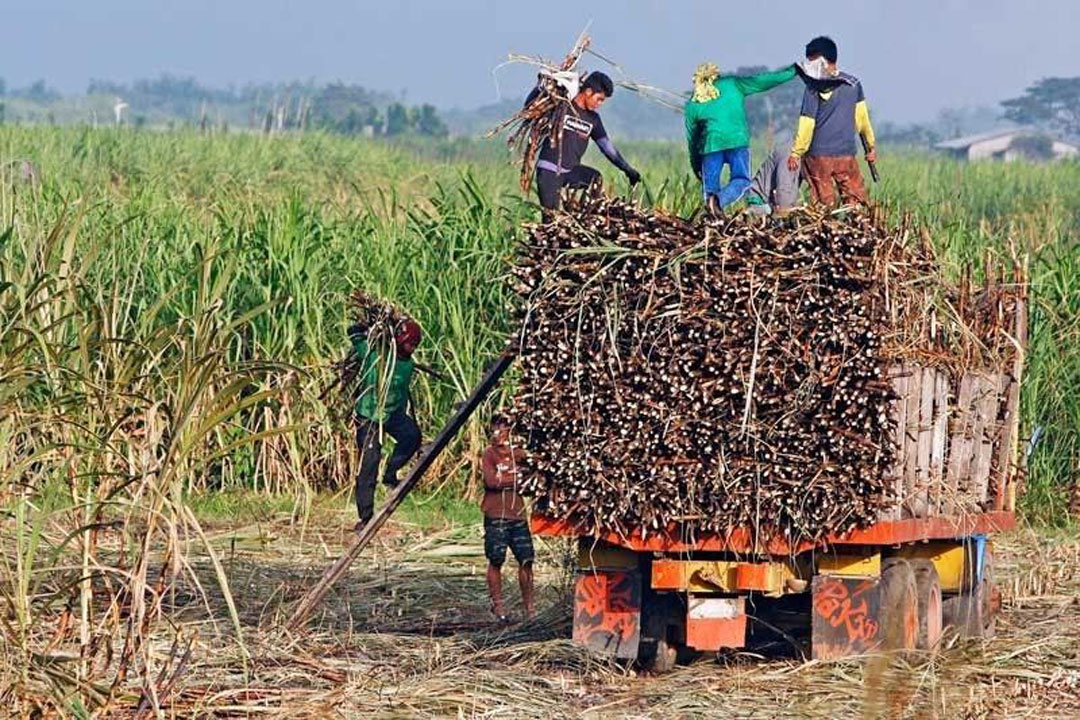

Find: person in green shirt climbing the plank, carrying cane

[349,320,420,532]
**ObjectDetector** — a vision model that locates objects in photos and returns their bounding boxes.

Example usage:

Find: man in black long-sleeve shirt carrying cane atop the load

[525,72,642,209]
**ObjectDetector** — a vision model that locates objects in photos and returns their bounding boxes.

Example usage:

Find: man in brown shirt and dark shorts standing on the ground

[481,416,536,623]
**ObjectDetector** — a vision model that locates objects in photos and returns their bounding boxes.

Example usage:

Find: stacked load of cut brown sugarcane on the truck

[511,198,954,546]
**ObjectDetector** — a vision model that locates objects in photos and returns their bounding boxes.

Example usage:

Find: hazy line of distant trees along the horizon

[0,71,1080,147]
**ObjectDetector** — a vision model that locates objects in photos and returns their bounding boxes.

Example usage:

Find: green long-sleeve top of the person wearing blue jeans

[686,65,795,172]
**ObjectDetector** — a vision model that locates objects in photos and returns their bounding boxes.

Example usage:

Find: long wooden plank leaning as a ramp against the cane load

[285,350,514,630]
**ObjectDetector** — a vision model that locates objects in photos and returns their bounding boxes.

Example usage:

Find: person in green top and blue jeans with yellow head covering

[685,63,795,215]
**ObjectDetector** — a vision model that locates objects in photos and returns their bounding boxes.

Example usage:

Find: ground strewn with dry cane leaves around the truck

[160,514,1080,720]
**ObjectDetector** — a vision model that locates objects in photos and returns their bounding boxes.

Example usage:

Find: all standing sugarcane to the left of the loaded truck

[0,128,521,717]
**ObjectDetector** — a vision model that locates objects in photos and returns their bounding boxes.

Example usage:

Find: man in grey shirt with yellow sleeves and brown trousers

[787,37,877,205]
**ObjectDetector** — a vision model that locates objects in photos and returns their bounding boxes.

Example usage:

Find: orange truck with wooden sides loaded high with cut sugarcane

[510,199,1026,669]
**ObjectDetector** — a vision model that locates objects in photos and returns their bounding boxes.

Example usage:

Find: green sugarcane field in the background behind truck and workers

[0,127,1080,511]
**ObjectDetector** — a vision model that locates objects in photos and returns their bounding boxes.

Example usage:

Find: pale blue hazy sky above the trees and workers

[0,0,1080,121]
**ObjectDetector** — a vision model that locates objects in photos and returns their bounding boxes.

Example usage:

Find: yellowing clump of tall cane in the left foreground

[0,218,291,717]
